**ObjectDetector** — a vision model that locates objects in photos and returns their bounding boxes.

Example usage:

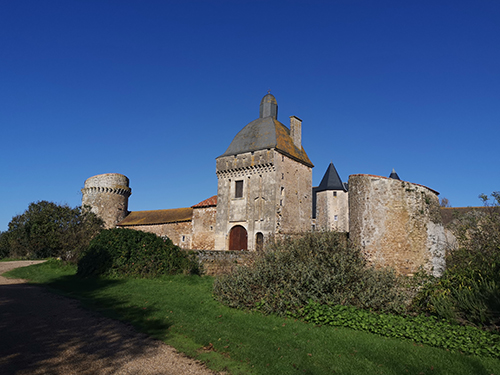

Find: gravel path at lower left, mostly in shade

[0,261,218,375]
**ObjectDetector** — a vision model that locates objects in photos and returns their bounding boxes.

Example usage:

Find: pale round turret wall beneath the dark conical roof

[316,190,349,232]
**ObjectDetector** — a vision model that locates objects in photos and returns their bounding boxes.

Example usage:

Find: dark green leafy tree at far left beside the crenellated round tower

[0,201,103,263]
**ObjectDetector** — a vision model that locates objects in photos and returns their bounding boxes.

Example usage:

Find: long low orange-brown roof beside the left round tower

[116,207,193,227]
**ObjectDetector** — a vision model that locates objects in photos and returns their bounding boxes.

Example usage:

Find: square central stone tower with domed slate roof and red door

[215,94,313,251]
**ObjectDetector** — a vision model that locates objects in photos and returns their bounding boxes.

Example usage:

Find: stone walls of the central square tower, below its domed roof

[215,150,312,250]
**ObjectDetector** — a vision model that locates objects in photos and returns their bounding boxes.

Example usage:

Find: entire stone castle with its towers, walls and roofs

[82,93,445,274]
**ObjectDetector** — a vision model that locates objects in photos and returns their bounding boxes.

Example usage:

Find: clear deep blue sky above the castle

[0,0,500,230]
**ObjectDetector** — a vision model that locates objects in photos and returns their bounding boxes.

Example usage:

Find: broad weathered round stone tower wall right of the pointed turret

[349,175,446,275]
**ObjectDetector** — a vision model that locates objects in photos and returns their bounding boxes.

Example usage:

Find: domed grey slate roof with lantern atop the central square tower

[219,94,314,167]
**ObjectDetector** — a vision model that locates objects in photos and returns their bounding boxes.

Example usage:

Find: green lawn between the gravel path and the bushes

[5,261,500,375]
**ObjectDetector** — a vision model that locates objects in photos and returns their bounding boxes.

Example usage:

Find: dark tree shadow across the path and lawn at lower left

[0,276,174,374]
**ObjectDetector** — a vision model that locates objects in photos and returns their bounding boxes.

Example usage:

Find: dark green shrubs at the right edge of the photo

[414,192,500,330]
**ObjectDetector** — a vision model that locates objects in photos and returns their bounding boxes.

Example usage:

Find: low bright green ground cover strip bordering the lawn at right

[296,303,500,358]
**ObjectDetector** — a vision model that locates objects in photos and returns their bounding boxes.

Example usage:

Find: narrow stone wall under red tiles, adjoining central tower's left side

[191,207,217,250]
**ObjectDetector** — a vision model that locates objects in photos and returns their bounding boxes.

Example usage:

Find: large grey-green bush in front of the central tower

[214,232,404,315]
